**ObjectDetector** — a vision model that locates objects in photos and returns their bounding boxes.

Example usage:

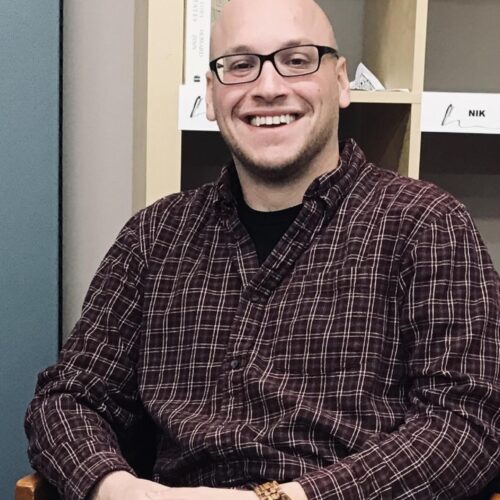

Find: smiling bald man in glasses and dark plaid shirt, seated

[26,0,500,500]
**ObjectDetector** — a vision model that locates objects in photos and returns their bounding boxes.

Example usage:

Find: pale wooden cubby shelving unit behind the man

[134,0,500,265]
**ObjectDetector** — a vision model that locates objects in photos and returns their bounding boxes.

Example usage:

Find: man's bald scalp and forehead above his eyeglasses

[210,0,336,59]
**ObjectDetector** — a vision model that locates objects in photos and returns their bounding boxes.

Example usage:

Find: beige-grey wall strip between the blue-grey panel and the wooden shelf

[63,0,134,336]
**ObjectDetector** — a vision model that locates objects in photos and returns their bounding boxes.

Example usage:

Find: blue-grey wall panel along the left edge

[0,0,59,492]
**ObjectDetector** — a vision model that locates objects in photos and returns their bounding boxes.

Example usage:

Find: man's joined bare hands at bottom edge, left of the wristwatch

[90,471,257,500]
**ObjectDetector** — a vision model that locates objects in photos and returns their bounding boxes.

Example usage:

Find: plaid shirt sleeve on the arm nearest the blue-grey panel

[25,215,145,499]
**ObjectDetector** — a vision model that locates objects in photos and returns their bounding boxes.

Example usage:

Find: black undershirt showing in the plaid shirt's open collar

[238,196,302,264]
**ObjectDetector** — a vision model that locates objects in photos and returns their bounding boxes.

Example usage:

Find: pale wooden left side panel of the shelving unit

[133,0,184,208]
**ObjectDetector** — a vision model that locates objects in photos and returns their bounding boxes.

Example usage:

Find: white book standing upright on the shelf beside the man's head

[184,0,229,84]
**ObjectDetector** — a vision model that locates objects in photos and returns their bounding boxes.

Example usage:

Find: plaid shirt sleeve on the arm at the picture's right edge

[298,205,500,500]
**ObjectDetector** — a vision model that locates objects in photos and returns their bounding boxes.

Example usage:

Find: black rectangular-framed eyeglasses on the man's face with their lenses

[210,45,339,85]
